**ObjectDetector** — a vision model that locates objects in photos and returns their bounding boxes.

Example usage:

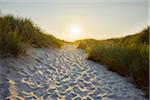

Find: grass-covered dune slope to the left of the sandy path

[0,15,62,56]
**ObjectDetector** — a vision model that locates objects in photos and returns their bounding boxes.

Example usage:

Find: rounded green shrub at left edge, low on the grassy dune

[0,32,27,56]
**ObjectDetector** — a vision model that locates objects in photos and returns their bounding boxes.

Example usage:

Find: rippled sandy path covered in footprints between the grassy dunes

[0,45,144,100]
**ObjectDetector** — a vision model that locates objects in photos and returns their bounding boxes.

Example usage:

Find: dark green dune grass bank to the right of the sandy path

[76,27,149,96]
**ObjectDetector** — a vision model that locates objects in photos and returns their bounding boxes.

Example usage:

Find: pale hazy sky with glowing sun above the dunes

[0,0,150,41]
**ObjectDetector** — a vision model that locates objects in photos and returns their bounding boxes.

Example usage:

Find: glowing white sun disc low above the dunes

[69,26,82,36]
